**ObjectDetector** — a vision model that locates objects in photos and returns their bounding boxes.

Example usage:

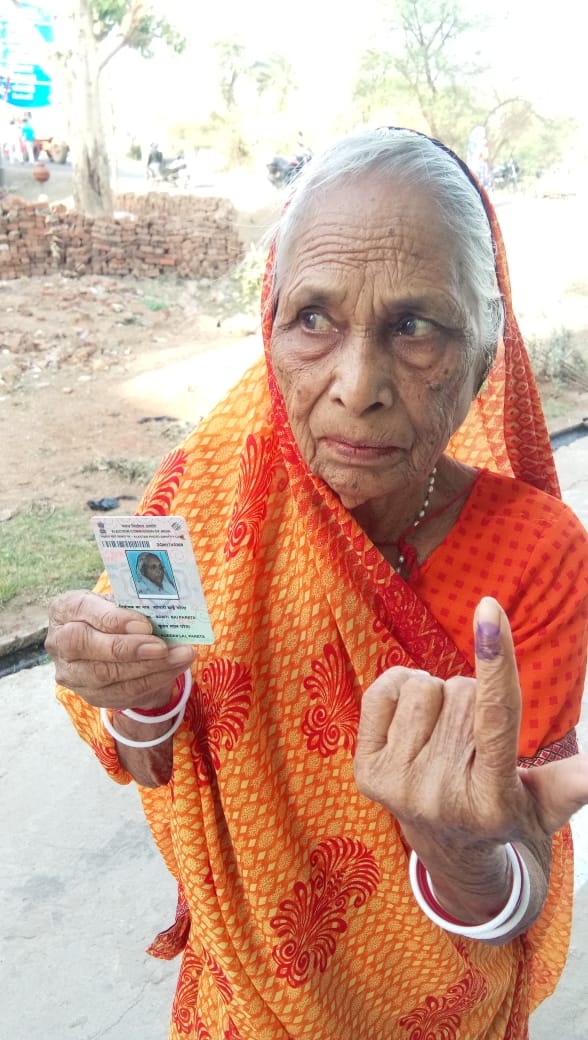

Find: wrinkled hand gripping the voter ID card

[45,591,196,710]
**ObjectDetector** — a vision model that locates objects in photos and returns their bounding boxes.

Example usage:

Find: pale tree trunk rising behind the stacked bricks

[72,0,112,216]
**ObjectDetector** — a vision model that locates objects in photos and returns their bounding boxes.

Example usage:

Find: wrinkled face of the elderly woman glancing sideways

[271,174,481,509]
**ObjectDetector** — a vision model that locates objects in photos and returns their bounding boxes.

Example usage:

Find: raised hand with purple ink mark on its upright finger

[355,597,588,919]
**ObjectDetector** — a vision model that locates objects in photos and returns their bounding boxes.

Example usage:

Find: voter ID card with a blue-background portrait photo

[92,516,214,644]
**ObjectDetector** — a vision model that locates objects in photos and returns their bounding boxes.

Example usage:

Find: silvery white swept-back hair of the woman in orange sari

[273,128,504,378]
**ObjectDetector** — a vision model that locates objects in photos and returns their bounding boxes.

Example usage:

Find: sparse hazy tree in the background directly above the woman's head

[353,0,576,164]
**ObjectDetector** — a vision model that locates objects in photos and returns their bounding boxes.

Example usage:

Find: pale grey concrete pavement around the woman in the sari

[0,438,588,1040]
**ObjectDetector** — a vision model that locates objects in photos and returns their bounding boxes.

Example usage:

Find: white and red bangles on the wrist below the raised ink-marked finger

[409,842,531,940]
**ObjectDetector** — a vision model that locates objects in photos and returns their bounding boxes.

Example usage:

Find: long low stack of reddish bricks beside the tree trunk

[0,191,244,280]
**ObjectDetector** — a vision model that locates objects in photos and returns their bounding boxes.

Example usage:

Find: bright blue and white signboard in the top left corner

[0,3,53,109]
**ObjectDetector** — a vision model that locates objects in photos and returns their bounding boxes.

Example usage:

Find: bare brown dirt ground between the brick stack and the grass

[0,277,261,516]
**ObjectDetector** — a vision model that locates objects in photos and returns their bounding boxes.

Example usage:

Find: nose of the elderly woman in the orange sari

[330,333,394,415]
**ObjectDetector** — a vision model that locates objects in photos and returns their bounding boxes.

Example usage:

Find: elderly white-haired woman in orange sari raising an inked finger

[47,130,588,1040]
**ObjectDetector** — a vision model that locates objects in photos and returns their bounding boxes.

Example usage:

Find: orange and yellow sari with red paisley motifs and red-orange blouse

[58,178,588,1040]
